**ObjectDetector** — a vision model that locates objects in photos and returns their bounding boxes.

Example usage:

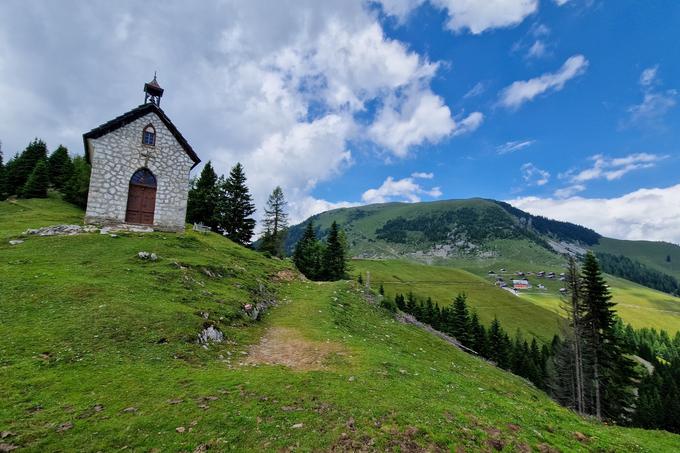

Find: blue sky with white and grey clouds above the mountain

[0,0,680,243]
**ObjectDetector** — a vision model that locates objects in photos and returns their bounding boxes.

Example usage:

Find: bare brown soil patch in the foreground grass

[246,327,343,371]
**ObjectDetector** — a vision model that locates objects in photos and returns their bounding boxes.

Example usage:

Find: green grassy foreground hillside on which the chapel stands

[0,200,680,452]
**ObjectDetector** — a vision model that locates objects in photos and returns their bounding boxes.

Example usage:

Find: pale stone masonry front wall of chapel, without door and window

[85,113,194,231]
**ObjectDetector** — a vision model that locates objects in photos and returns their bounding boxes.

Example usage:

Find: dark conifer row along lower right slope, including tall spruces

[379,253,680,432]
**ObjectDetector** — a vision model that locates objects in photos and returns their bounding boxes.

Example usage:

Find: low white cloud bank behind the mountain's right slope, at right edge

[509,184,680,244]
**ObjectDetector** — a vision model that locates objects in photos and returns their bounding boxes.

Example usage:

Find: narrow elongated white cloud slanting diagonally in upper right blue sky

[499,55,588,109]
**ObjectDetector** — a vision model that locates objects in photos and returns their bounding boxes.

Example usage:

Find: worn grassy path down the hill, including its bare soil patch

[246,282,346,371]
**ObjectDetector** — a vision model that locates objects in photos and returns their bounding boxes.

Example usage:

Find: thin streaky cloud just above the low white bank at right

[560,153,666,183]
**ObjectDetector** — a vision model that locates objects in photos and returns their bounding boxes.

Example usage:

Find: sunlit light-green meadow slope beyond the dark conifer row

[352,260,680,341]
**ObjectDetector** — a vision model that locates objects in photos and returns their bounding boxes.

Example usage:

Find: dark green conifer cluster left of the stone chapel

[0,138,90,208]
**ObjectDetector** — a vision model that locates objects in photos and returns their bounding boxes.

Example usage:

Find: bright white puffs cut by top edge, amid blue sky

[379,0,538,35]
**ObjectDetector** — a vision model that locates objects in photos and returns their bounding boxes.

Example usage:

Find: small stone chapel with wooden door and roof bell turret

[83,75,200,231]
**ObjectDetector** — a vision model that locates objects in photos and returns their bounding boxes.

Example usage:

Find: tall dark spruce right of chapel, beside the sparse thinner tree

[217,163,255,245]
